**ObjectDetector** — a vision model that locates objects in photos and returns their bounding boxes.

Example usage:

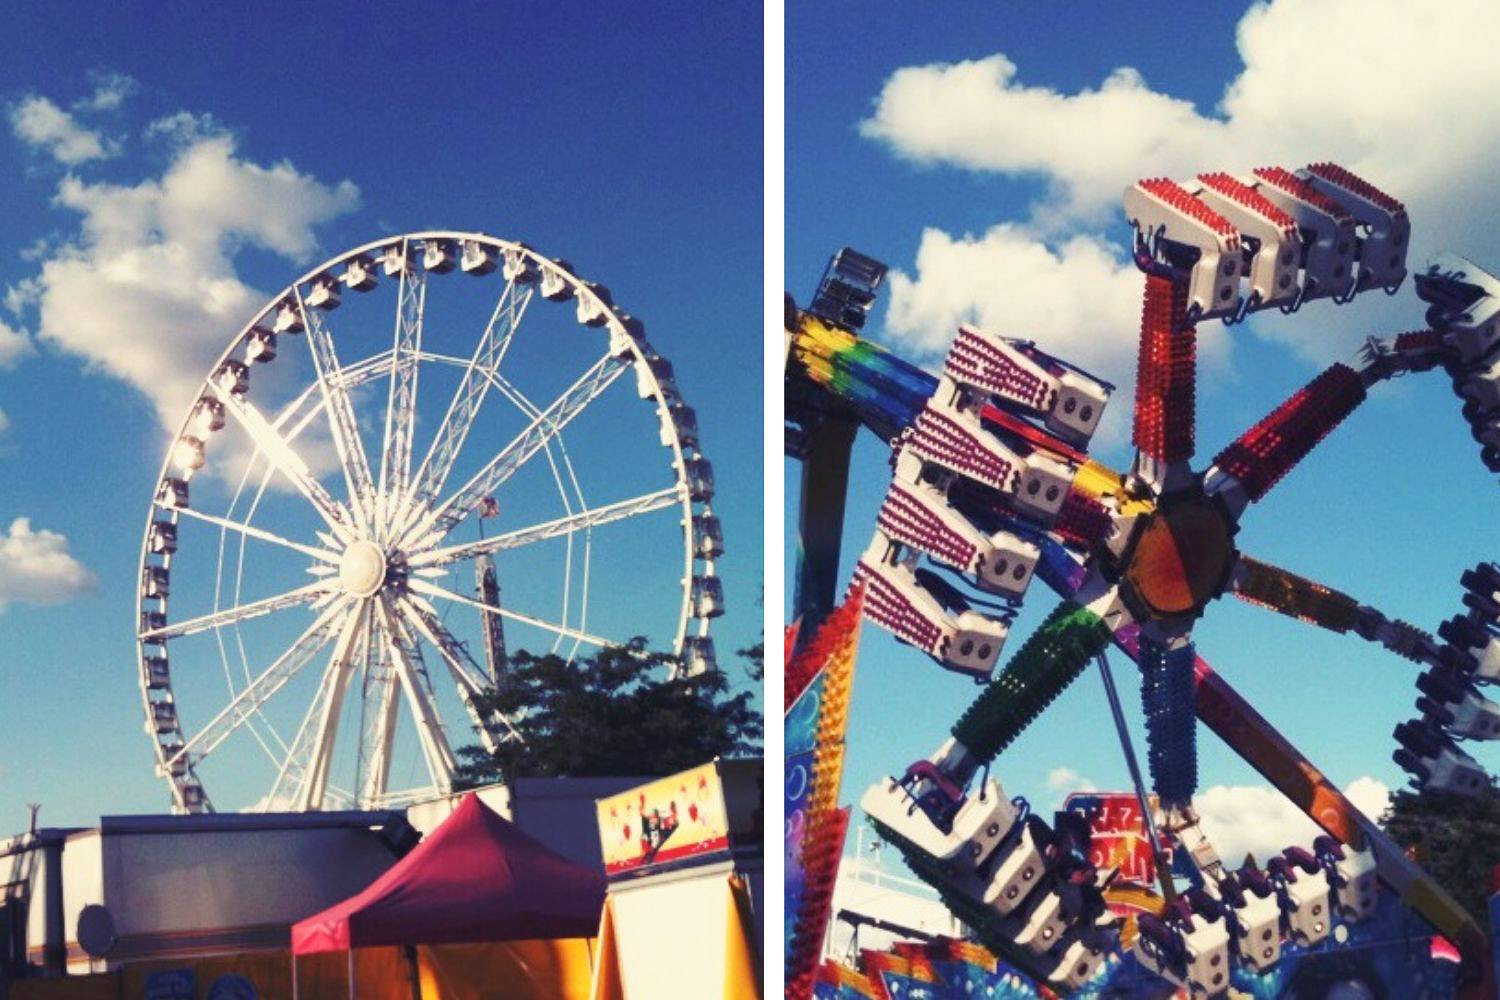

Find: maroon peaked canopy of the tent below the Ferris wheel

[291,793,605,955]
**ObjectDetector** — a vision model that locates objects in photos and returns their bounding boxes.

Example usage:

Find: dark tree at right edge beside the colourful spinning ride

[1380,778,1500,927]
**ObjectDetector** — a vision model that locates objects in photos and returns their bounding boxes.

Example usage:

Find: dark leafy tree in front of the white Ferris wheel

[453,639,762,787]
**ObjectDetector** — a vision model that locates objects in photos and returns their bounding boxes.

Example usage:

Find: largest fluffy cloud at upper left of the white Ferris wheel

[8,133,359,426]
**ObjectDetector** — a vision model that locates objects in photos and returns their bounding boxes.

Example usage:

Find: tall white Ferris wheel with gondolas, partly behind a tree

[137,232,723,813]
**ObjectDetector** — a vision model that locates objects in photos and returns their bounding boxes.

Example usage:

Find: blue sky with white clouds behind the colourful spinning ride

[783,0,1500,855]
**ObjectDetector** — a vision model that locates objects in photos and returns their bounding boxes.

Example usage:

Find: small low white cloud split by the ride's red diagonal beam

[1193,777,1391,868]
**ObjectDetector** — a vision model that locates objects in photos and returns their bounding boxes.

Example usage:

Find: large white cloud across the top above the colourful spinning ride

[863,0,1500,233]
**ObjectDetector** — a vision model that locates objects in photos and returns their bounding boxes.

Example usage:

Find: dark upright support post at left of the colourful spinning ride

[792,415,860,637]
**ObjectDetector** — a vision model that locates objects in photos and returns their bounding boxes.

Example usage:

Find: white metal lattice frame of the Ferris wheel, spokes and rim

[137,231,723,811]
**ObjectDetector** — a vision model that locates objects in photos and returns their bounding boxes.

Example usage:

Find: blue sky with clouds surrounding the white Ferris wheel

[0,3,764,832]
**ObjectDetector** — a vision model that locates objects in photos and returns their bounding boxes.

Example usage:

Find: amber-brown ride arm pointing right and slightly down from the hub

[1229,553,1442,666]
